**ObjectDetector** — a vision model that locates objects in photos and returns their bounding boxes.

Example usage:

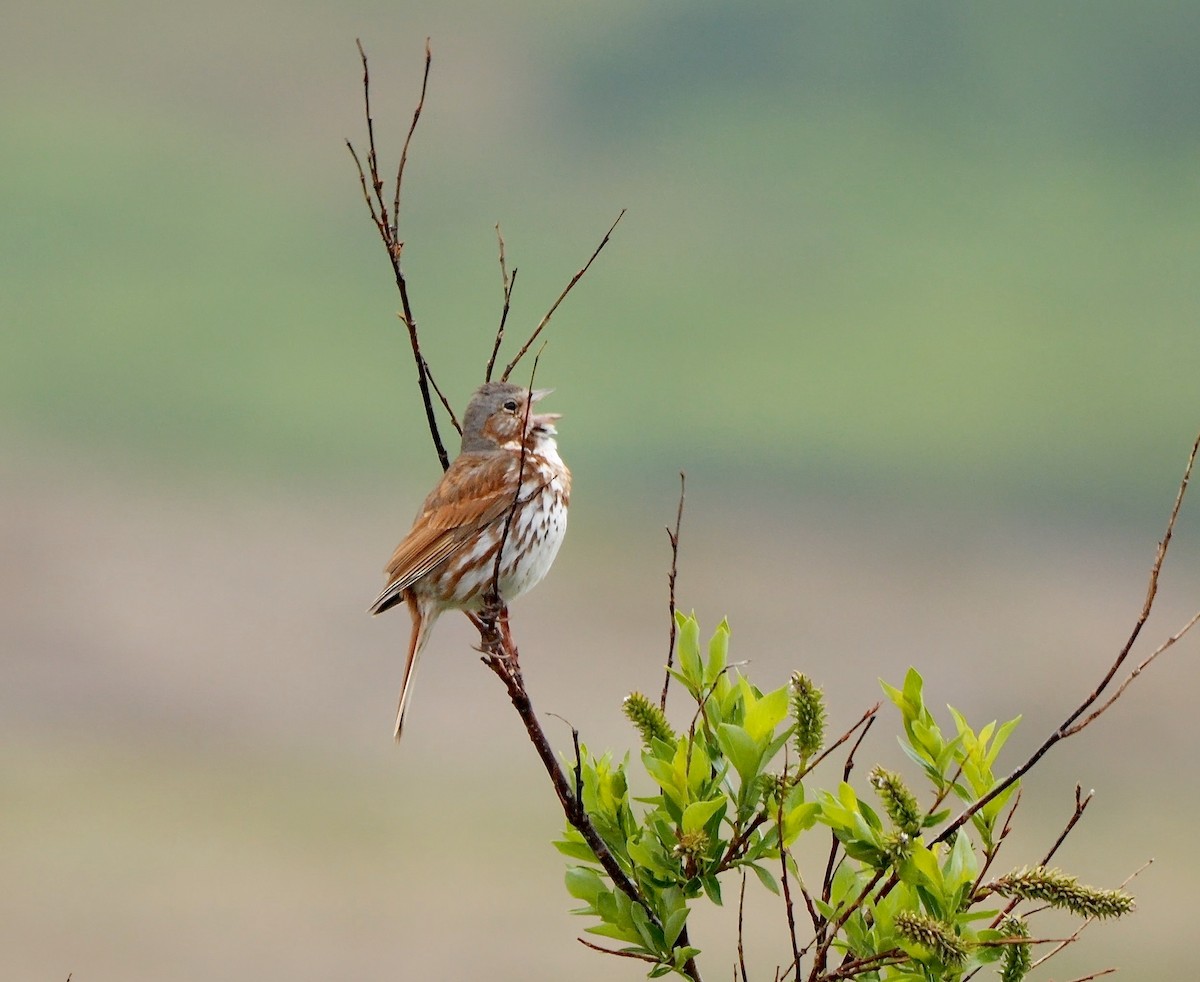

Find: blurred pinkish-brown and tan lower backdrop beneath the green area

[0,450,1200,982]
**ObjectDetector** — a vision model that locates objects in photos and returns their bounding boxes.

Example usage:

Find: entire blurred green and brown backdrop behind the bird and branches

[7,0,1200,982]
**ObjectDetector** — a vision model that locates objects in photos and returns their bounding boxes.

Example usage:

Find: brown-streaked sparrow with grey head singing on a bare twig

[370,382,571,740]
